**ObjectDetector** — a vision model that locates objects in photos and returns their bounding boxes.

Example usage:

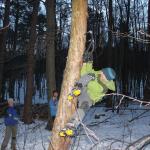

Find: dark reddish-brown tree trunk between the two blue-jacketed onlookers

[24,0,39,124]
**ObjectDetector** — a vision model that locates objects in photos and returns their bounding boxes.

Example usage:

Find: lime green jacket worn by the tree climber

[81,62,115,104]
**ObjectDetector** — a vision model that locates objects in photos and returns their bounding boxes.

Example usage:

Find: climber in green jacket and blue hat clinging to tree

[59,53,116,137]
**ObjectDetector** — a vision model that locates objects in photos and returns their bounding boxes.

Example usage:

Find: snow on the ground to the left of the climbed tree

[0,119,51,150]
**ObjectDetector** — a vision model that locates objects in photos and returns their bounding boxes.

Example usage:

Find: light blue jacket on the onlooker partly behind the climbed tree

[49,98,58,117]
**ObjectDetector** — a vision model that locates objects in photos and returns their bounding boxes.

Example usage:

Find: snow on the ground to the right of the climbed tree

[71,105,150,150]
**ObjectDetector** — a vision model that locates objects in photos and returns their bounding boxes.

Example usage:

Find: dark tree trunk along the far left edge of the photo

[0,0,10,100]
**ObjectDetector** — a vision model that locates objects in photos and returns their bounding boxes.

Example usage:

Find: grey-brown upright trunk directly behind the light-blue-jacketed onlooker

[46,0,56,129]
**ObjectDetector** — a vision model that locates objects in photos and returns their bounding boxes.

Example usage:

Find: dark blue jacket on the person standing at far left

[4,107,18,126]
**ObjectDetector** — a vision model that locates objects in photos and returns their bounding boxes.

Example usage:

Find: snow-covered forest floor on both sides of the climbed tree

[0,105,150,150]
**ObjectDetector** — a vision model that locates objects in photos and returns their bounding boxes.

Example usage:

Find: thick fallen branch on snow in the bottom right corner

[125,135,150,150]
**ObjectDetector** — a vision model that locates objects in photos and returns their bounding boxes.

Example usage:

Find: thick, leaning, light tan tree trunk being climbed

[49,0,87,150]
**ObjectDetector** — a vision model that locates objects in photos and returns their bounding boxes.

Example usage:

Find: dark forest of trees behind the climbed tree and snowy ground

[0,0,150,122]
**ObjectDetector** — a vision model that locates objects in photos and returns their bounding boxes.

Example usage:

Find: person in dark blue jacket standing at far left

[1,98,18,150]
